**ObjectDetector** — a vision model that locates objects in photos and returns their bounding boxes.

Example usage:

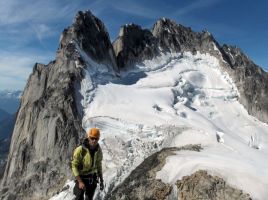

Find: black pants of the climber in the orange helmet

[73,174,97,200]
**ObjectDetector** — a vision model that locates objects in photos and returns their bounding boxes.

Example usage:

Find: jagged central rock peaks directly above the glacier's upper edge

[113,18,219,68]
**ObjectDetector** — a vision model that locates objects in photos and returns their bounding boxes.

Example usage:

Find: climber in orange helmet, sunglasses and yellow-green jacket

[71,128,104,200]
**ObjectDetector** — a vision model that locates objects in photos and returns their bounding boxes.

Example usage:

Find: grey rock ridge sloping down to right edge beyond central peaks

[220,45,268,123]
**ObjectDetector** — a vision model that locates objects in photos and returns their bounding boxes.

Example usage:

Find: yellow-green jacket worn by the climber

[72,142,103,177]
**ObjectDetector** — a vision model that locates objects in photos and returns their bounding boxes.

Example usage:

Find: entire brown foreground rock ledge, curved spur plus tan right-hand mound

[105,145,251,200]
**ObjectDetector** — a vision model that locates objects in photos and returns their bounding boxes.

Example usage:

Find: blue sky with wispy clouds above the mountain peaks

[0,0,268,90]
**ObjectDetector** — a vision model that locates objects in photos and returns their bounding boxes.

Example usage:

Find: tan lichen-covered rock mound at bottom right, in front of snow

[176,170,251,200]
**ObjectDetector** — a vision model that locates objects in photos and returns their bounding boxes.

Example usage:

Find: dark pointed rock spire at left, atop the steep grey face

[59,11,118,71]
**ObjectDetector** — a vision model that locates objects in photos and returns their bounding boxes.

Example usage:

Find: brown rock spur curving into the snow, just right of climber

[105,145,202,200]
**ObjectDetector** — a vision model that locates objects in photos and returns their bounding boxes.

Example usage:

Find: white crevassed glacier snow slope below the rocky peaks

[52,53,268,199]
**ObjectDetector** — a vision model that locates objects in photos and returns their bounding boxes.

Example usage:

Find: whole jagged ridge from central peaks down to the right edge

[113,18,268,123]
